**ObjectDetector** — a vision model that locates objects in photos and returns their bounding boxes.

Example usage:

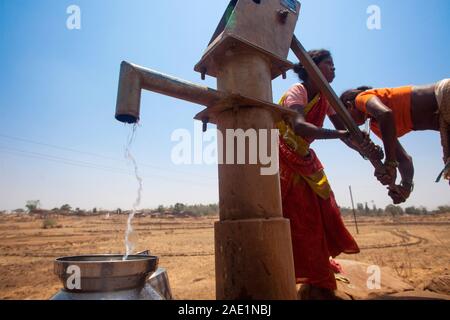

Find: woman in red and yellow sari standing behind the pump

[278,50,376,299]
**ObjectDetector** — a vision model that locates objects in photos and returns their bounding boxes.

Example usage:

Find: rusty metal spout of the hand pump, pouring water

[116,61,228,123]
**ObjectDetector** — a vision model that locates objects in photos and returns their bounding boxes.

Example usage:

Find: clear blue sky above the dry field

[0,0,450,209]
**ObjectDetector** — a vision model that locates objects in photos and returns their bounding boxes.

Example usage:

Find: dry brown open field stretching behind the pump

[0,214,450,299]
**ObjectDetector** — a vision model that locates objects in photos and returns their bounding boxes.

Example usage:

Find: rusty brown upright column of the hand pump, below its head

[208,29,296,300]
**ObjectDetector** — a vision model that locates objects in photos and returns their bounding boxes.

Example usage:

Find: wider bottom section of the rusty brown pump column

[215,218,297,300]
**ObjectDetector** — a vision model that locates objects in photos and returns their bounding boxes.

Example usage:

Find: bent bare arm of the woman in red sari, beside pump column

[291,105,349,140]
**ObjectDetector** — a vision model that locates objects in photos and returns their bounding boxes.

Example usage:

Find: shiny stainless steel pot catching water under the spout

[52,255,171,300]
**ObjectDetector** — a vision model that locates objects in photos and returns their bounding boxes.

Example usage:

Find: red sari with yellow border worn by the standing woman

[280,85,359,290]
